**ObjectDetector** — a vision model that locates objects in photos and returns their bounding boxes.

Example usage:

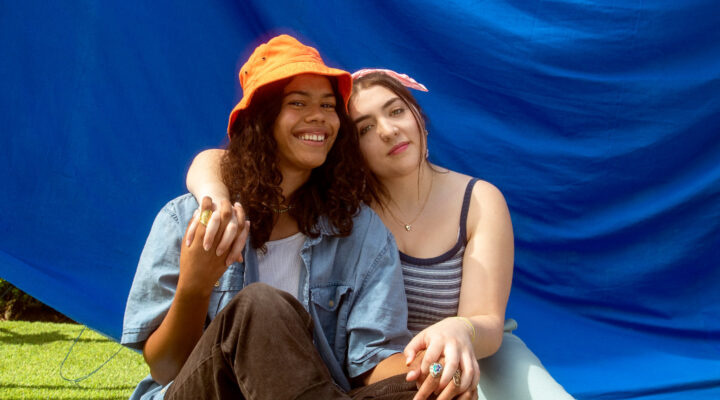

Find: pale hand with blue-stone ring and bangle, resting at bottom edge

[404,318,480,400]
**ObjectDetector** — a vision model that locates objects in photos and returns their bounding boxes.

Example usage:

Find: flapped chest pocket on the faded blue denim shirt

[310,285,351,348]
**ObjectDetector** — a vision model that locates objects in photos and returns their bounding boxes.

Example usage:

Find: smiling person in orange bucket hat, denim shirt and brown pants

[121,35,424,399]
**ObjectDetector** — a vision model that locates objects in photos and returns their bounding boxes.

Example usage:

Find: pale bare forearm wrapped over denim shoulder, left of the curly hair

[186,149,230,202]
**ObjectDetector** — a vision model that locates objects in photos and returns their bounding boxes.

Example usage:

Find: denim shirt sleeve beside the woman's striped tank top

[347,218,411,378]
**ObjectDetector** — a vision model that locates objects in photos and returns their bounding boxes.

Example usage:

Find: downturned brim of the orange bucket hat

[227,61,352,135]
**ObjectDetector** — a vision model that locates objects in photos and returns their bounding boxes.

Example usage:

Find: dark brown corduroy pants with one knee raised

[165,284,417,400]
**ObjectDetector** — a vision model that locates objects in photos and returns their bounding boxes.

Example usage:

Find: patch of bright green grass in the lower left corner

[0,321,148,400]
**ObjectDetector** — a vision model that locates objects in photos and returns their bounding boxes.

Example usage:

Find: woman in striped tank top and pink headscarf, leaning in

[187,64,572,400]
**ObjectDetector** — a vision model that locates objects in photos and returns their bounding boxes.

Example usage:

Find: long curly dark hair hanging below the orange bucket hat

[221,77,371,250]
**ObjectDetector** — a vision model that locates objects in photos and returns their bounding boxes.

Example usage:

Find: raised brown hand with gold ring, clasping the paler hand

[178,197,233,295]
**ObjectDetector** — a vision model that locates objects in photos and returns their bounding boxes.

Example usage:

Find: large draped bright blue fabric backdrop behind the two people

[0,0,720,400]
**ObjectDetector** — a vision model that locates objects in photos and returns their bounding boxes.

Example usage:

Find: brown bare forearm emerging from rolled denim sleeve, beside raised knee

[143,288,210,385]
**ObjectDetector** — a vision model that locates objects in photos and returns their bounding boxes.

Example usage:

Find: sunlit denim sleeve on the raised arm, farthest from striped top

[120,201,185,350]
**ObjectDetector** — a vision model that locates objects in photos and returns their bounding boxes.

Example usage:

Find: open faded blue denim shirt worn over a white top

[121,194,410,399]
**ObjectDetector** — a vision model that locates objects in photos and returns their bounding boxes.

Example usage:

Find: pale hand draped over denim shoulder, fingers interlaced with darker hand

[185,197,250,265]
